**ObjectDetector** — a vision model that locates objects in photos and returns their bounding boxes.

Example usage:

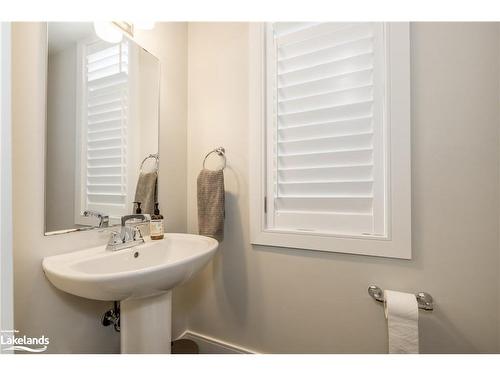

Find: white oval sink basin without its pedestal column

[43,233,218,301]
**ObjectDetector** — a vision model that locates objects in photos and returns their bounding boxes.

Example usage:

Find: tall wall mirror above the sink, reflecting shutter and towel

[45,22,160,232]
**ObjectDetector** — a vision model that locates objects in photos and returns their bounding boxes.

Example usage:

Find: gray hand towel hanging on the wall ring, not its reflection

[197,169,225,242]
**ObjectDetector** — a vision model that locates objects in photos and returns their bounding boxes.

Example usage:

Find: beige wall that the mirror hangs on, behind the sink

[12,23,187,353]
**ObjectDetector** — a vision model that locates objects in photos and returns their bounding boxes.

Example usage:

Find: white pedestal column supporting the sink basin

[120,291,172,354]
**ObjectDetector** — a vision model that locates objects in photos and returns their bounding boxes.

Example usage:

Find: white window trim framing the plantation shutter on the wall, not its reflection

[249,22,411,259]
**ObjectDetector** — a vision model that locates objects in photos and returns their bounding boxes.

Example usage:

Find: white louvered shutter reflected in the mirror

[81,41,129,217]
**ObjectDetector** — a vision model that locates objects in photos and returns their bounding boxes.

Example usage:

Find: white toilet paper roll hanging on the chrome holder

[384,290,418,354]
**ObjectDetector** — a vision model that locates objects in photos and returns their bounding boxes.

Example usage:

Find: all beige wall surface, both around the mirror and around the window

[13,23,500,353]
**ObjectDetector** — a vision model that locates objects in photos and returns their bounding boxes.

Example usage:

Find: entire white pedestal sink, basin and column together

[42,233,218,353]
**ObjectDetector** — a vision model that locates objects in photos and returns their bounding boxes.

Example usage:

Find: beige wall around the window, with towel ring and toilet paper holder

[182,23,499,353]
